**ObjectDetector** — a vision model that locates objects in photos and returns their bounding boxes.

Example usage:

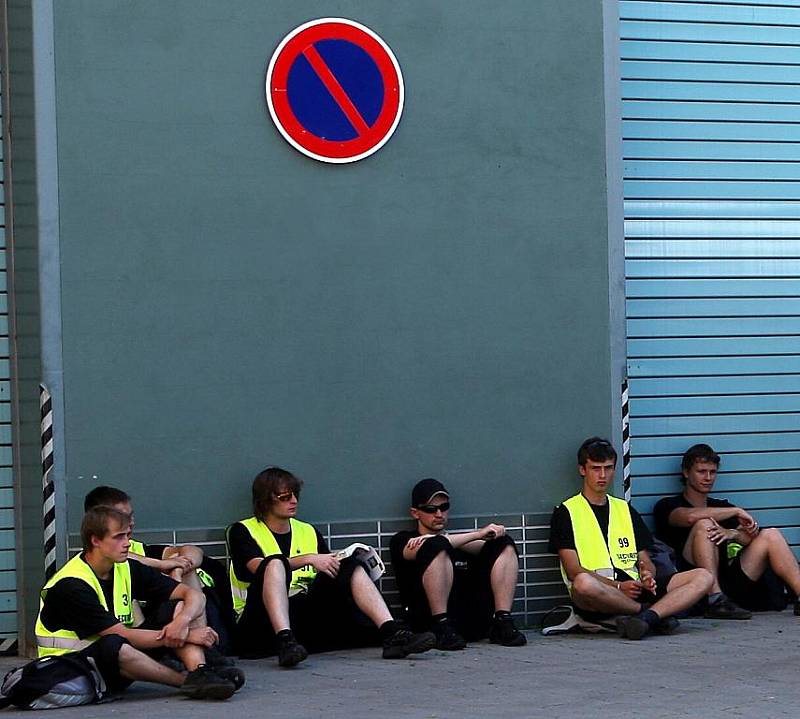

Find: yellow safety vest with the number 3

[36,554,134,657]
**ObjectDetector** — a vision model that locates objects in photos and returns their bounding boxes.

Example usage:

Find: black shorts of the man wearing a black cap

[400,535,517,641]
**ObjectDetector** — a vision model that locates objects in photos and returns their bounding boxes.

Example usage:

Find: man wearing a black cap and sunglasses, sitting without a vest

[390,478,527,650]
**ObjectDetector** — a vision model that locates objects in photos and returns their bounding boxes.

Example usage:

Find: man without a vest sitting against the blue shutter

[653,444,800,619]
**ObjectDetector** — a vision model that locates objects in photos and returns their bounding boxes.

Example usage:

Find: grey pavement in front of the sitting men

[0,611,800,719]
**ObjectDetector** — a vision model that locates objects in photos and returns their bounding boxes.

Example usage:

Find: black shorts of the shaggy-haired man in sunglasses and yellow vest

[235,555,380,659]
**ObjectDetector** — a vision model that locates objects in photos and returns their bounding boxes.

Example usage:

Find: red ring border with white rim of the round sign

[265,17,405,163]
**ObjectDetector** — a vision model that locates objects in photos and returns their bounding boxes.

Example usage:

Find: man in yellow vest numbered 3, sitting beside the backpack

[36,507,244,699]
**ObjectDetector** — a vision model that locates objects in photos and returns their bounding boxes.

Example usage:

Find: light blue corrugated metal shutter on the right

[619,0,800,545]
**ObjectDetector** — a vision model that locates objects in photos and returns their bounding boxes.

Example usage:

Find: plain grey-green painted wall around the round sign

[55,0,612,528]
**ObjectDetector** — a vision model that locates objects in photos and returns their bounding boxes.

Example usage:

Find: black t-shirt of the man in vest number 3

[41,560,178,639]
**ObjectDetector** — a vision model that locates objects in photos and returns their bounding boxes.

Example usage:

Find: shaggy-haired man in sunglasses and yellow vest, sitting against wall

[228,467,436,667]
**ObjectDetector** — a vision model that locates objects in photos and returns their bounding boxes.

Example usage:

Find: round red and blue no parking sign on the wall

[266,18,403,163]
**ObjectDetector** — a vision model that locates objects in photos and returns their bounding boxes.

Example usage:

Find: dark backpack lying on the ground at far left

[0,654,106,709]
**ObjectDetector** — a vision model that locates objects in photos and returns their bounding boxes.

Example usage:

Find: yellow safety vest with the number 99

[561,493,639,591]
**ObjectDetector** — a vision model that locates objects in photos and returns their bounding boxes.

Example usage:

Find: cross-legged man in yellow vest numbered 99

[550,437,712,639]
